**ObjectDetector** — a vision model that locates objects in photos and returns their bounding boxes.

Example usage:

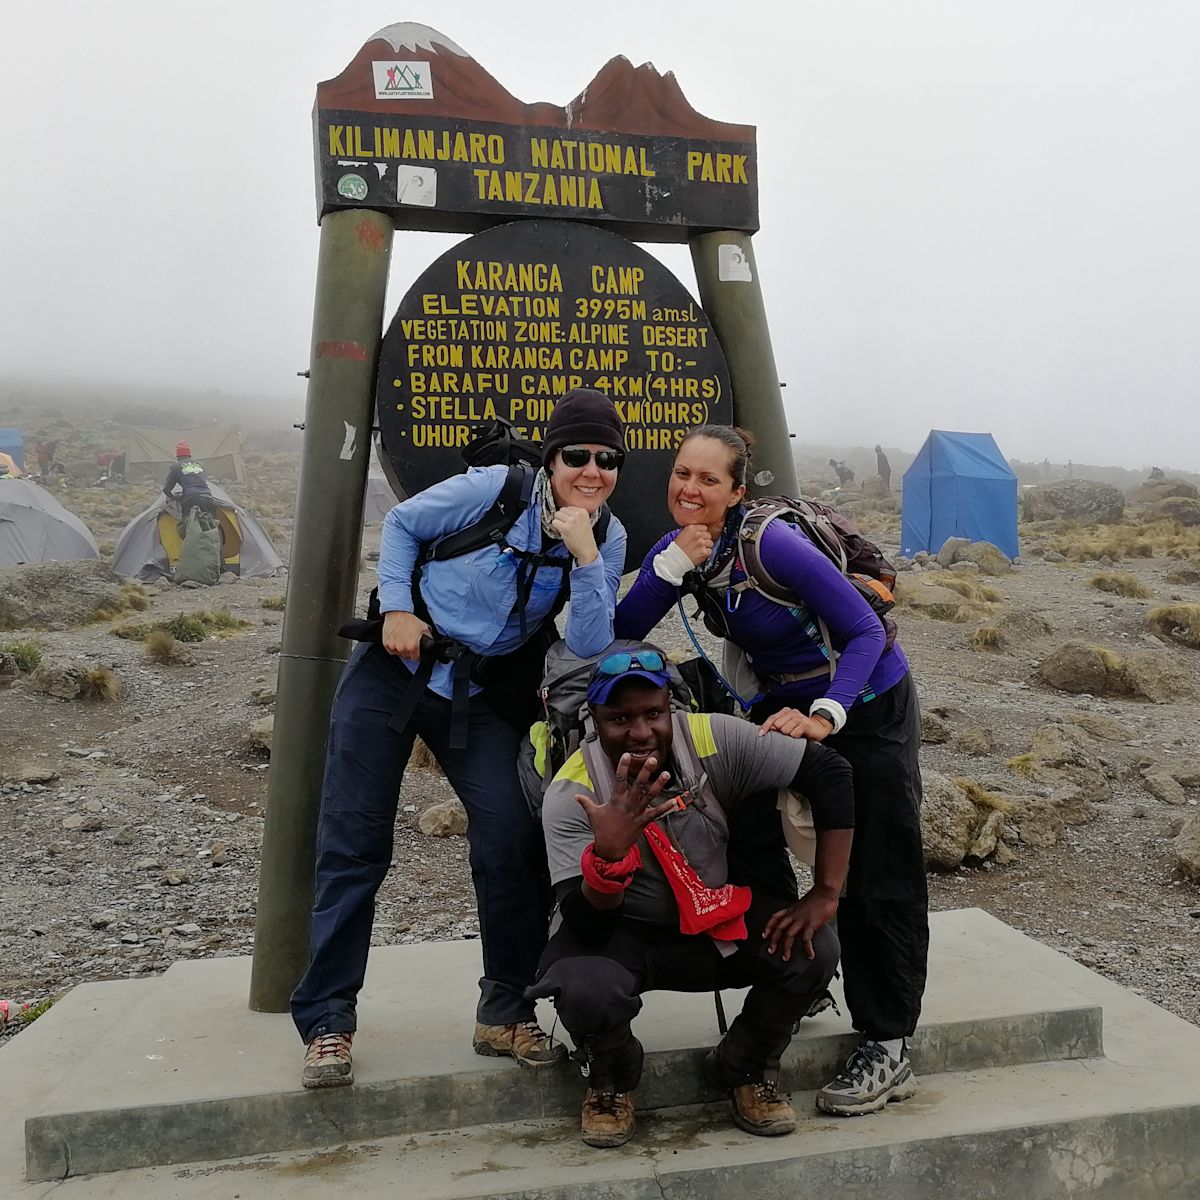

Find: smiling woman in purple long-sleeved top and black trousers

[614,425,929,1115]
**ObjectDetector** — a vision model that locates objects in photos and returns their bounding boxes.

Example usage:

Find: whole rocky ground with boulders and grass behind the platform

[0,468,1200,1036]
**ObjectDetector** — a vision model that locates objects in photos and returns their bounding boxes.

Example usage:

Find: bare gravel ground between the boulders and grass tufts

[0,499,1200,1037]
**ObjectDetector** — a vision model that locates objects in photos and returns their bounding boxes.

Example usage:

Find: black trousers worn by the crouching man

[526,898,838,1092]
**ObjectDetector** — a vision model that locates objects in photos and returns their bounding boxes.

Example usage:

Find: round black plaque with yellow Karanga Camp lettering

[376,221,732,570]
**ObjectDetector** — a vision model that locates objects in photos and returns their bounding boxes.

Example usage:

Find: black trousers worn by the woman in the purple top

[744,674,929,1039]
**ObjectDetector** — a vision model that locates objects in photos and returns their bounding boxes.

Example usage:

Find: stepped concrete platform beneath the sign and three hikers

[7,910,1200,1200]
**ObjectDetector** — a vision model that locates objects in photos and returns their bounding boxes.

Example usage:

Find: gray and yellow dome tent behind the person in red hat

[111,482,283,581]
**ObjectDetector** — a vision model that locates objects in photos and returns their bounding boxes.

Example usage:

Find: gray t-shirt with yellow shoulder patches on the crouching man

[541,713,808,925]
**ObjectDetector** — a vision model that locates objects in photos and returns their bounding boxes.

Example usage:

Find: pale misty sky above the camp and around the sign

[0,0,1200,469]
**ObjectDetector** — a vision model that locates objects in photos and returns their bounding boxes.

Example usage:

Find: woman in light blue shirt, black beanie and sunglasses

[292,389,625,1087]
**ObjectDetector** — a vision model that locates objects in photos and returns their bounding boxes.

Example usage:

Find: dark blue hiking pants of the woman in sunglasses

[292,643,551,1042]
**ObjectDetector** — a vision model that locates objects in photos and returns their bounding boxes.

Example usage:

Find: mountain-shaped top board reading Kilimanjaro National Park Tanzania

[313,24,758,241]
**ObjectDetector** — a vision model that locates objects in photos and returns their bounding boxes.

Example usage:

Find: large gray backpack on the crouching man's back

[517,637,692,816]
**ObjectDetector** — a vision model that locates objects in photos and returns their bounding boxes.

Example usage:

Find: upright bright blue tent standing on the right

[900,430,1020,558]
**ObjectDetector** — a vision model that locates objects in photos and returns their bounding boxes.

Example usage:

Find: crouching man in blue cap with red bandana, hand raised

[527,648,854,1146]
